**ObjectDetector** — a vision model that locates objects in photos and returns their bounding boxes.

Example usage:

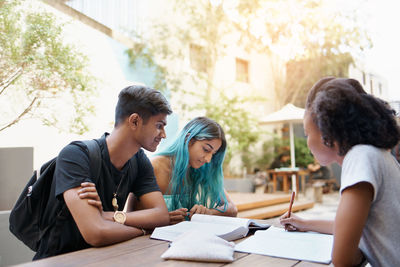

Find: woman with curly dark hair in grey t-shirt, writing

[280,77,400,266]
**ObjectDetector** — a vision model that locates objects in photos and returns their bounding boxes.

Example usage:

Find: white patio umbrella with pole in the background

[260,103,305,194]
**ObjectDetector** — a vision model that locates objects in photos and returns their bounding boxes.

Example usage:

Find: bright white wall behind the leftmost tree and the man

[0,1,133,169]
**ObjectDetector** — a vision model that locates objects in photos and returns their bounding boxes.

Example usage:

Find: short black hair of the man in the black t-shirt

[115,85,172,126]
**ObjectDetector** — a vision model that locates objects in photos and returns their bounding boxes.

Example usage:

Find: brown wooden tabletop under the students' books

[14,231,328,267]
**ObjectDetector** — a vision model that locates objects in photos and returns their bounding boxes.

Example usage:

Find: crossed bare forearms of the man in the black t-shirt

[63,183,169,246]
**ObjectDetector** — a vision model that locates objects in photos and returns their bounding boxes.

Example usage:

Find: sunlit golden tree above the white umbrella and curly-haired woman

[235,0,372,108]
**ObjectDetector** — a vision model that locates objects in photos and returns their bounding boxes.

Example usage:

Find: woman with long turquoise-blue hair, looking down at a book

[151,117,237,224]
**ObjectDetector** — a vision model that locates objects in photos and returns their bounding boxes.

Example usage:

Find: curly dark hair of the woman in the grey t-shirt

[306,77,400,156]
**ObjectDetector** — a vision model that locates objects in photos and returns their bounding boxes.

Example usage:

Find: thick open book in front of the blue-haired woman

[150,214,270,244]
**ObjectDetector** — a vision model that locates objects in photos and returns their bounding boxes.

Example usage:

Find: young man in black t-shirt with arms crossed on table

[34,86,172,259]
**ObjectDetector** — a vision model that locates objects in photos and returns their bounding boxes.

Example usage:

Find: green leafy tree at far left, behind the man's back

[0,0,94,133]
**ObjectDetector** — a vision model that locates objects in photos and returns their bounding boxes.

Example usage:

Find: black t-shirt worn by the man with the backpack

[34,133,160,259]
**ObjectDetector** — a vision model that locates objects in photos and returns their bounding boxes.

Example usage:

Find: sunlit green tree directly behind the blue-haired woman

[128,0,263,170]
